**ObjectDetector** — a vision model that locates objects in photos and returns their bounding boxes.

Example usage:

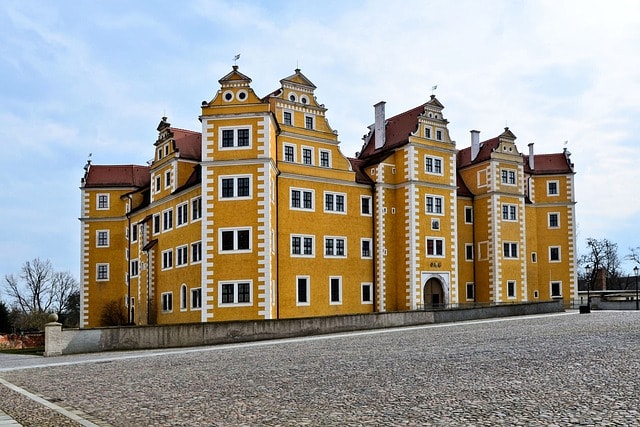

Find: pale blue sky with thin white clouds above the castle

[0,0,640,278]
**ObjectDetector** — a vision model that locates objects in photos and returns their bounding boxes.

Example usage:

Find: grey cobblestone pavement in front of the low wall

[0,312,640,426]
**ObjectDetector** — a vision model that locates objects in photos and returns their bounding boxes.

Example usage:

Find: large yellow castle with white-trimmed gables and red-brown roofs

[80,66,577,327]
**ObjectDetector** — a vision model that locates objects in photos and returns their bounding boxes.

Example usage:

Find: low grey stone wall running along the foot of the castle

[44,301,564,356]
